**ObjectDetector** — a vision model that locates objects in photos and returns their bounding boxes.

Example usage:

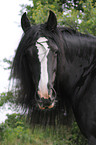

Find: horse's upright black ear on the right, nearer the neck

[47,10,57,31]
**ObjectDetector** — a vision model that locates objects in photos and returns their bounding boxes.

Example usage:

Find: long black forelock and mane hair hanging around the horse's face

[11,23,65,125]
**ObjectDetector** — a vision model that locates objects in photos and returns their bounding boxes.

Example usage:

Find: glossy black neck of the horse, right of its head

[59,32,96,101]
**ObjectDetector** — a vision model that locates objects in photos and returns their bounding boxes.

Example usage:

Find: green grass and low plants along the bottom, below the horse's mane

[0,114,87,145]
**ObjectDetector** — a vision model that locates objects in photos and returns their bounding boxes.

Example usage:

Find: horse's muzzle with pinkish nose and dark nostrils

[37,89,56,110]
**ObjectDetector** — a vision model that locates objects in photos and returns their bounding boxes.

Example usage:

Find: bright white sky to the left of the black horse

[0,0,32,123]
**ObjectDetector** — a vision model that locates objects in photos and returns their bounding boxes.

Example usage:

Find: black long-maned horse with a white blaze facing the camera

[12,11,96,145]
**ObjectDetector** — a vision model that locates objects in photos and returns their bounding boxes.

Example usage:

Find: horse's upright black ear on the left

[21,12,31,32]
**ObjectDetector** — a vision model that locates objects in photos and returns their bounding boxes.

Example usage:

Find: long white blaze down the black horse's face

[36,37,49,95]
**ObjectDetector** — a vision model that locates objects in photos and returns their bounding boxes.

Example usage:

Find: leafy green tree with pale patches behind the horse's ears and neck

[21,0,96,35]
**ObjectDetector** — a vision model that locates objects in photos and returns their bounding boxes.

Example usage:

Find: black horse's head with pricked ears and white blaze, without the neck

[13,11,61,110]
